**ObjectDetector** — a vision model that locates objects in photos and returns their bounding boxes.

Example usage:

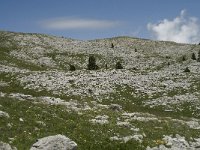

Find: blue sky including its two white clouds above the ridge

[0,0,200,43]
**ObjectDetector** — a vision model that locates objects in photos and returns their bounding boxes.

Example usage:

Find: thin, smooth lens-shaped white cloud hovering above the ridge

[41,18,120,30]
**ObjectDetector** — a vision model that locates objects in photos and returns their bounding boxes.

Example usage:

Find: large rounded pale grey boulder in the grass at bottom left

[30,134,77,150]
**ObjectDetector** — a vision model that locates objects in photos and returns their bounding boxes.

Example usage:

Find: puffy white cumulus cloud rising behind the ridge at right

[147,10,200,43]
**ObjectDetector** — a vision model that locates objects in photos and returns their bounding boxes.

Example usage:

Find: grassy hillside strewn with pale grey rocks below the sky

[0,32,200,150]
